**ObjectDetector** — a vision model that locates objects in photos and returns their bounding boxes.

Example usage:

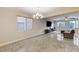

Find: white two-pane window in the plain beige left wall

[17,17,32,31]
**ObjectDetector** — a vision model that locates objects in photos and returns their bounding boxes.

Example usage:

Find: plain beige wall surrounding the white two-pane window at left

[0,8,45,44]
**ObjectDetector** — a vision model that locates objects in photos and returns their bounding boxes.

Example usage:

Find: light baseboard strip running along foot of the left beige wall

[0,33,44,47]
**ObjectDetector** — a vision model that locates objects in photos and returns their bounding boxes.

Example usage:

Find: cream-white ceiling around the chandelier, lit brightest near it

[7,7,79,17]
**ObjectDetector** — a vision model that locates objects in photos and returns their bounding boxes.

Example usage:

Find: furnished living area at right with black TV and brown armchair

[41,12,79,47]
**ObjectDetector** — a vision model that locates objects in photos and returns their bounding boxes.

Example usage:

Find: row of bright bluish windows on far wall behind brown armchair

[55,20,78,30]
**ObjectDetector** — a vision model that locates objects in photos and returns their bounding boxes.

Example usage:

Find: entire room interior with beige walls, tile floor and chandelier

[0,7,79,52]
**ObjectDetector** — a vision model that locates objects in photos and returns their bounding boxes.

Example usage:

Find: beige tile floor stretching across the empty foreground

[0,34,79,52]
